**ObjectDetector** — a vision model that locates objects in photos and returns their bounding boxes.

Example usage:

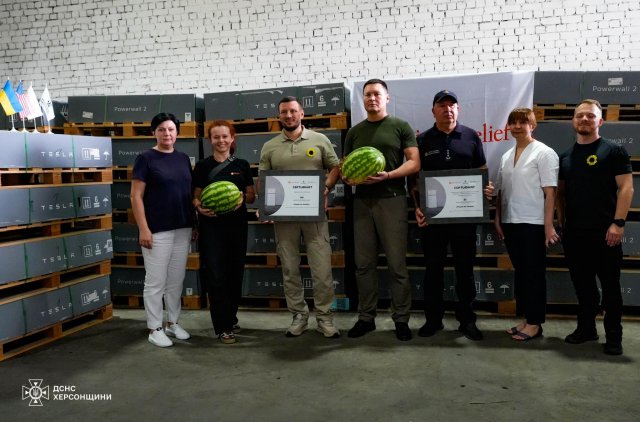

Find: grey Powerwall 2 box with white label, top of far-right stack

[582,71,640,104]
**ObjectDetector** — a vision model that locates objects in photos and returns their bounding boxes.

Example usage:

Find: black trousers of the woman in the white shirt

[502,224,547,325]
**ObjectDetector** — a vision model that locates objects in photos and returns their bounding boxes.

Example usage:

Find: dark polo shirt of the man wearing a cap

[417,124,487,171]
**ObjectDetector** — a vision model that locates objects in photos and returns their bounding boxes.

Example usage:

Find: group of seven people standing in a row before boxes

[131,79,633,355]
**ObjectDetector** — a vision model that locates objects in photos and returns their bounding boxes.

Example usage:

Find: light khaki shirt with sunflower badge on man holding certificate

[258,128,340,171]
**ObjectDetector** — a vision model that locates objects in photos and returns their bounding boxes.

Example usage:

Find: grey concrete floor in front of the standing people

[0,310,640,422]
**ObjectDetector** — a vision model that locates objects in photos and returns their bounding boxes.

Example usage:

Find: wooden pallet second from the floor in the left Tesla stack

[0,260,111,300]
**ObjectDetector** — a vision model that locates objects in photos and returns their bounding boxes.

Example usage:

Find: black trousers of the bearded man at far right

[563,230,622,341]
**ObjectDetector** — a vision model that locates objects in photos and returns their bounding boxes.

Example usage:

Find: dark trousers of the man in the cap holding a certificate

[420,224,476,324]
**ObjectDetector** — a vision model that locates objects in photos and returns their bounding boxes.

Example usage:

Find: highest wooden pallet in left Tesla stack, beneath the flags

[0,168,113,186]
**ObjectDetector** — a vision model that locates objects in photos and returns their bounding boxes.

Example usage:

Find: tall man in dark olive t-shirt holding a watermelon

[344,79,420,341]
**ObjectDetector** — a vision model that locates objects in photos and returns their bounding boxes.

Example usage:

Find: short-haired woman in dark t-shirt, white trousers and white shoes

[131,113,193,347]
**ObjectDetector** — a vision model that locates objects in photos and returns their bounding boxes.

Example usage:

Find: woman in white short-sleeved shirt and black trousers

[485,108,559,341]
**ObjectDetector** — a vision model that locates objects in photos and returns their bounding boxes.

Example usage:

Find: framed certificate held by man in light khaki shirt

[258,170,327,221]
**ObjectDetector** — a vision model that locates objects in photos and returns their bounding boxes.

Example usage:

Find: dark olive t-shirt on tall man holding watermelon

[344,116,418,198]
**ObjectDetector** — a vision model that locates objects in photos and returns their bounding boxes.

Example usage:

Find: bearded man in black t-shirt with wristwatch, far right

[558,100,633,355]
